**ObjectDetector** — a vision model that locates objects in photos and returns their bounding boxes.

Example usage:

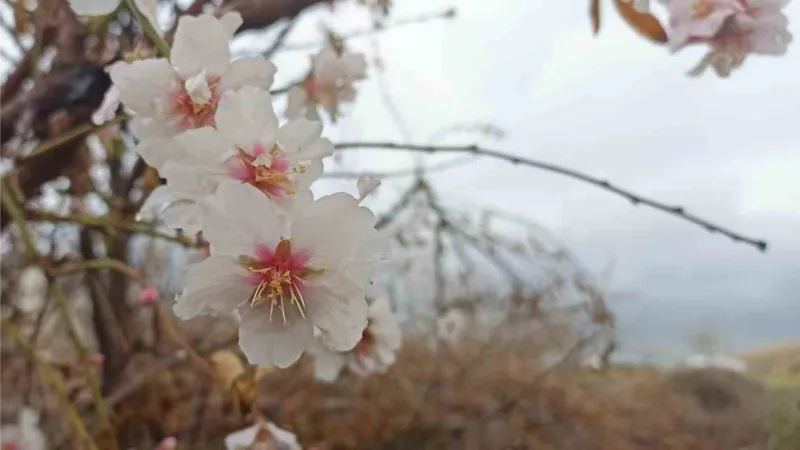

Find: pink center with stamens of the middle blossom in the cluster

[231,144,305,199]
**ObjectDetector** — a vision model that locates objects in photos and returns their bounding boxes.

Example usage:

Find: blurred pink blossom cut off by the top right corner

[669,0,792,77]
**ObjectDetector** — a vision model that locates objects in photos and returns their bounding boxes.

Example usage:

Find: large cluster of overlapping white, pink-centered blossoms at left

[78,4,399,384]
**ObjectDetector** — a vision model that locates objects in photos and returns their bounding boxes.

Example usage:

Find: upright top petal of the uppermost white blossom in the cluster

[170,14,232,80]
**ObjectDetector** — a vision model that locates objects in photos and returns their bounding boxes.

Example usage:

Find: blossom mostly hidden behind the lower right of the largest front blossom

[310,298,402,382]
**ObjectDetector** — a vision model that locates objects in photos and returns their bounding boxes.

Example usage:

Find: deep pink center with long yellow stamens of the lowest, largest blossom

[239,239,322,323]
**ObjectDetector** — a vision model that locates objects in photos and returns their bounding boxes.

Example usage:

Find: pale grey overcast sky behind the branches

[277,0,800,355]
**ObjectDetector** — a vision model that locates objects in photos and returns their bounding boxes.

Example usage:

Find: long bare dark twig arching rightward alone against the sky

[336,142,768,252]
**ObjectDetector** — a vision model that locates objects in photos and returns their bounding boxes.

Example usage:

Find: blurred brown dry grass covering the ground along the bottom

[0,341,767,450]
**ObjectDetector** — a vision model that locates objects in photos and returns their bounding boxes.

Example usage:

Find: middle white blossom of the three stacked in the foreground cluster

[155,86,333,232]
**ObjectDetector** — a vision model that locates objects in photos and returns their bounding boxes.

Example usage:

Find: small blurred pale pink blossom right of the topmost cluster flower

[286,47,367,121]
